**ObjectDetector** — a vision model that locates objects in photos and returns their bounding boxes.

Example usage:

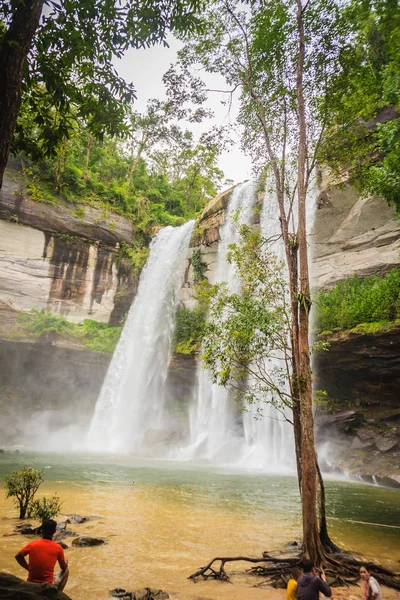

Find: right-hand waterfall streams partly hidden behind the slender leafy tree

[175,182,294,472]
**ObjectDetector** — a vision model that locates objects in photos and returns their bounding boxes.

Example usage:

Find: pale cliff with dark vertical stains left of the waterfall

[0,166,138,325]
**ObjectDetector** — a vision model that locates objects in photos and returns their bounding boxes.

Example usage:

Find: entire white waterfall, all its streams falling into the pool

[87,181,310,472]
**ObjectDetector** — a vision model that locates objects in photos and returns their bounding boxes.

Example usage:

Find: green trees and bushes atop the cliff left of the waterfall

[22,117,223,238]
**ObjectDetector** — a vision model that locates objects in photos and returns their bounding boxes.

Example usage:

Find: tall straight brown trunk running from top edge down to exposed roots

[296,0,323,565]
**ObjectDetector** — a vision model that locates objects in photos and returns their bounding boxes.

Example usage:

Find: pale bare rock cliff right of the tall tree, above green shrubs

[310,178,400,289]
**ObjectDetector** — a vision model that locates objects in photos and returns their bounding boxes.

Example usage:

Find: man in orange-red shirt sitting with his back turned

[15,519,69,591]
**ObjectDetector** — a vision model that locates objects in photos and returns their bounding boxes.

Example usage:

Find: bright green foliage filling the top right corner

[320,0,400,211]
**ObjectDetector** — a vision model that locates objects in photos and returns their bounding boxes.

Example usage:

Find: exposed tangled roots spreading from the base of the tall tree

[188,552,400,590]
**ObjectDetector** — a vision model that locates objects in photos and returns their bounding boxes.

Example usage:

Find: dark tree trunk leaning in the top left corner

[0,0,43,187]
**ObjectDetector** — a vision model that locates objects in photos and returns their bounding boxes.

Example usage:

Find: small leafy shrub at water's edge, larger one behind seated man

[4,467,43,519]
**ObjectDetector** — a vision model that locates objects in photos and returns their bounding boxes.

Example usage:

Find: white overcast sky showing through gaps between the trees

[115,36,251,188]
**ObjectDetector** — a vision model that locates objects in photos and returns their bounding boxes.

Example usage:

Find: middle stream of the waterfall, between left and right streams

[178,181,256,462]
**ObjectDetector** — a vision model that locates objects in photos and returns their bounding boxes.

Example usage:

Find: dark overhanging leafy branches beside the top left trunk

[0,0,202,156]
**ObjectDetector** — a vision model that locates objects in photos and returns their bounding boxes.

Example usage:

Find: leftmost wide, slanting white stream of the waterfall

[86,221,194,452]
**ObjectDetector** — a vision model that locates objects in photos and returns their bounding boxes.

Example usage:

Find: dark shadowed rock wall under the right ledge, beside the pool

[314,325,400,486]
